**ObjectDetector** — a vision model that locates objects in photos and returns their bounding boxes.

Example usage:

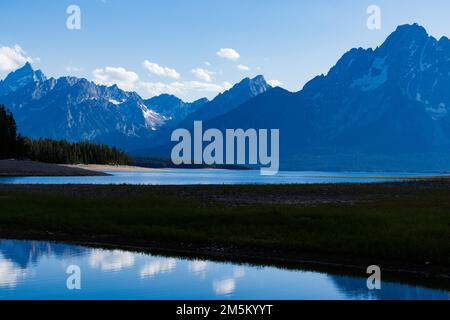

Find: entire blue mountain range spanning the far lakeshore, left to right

[0,24,450,171]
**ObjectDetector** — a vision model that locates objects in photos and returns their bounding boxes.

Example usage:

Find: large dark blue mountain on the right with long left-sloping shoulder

[148,24,450,170]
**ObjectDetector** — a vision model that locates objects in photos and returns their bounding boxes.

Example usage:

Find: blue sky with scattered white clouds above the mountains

[0,0,450,101]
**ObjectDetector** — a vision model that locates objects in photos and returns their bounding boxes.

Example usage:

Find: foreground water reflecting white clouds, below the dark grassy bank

[0,240,450,300]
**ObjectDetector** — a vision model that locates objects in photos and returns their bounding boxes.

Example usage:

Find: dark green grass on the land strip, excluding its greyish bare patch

[0,186,450,266]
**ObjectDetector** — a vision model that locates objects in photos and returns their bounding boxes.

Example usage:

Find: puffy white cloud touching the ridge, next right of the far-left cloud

[92,67,139,91]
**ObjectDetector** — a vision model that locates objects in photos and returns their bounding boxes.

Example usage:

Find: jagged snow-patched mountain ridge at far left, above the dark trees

[0,63,166,149]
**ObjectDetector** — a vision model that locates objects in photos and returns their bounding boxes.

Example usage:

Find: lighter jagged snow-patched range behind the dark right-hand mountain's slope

[0,63,269,151]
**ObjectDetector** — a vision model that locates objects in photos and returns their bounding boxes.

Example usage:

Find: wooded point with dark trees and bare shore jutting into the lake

[0,104,249,177]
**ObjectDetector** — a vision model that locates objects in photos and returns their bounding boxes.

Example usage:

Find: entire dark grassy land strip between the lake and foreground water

[0,180,450,278]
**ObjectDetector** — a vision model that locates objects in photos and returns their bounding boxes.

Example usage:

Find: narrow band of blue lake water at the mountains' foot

[0,169,444,185]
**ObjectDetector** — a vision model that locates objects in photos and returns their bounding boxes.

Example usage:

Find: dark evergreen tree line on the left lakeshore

[0,105,131,165]
